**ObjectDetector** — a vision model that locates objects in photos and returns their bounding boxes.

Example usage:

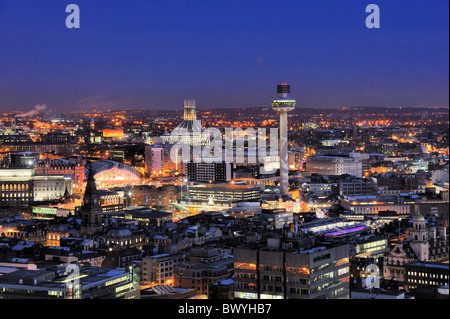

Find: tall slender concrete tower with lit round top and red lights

[272,83,295,194]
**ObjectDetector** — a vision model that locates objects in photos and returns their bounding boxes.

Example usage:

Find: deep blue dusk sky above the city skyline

[0,0,449,111]
